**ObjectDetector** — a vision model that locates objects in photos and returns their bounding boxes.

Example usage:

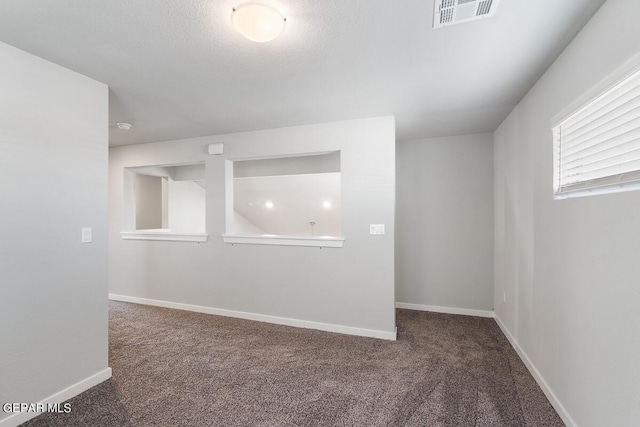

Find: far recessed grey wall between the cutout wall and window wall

[396,134,493,310]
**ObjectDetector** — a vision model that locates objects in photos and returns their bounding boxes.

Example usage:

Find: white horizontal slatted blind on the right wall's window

[553,70,640,194]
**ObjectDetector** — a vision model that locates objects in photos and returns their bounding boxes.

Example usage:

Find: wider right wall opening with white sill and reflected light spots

[225,152,344,247]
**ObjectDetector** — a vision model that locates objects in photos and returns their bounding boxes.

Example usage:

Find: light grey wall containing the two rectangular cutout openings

[109,117,395,332]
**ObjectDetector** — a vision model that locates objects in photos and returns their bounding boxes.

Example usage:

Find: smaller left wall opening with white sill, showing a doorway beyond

[122,164,206,241]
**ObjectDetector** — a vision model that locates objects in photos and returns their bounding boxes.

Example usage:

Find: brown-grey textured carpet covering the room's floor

[24,302,563,427]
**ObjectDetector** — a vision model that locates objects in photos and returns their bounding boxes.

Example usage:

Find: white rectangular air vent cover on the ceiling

[433,0,499,28]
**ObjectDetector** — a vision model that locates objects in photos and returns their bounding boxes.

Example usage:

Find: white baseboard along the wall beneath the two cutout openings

[109,294,397,341]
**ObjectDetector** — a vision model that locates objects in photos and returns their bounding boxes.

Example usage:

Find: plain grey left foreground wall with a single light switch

[0,43,108,420]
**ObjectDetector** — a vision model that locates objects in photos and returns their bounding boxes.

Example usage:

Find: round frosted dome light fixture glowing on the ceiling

[231,1,287,43]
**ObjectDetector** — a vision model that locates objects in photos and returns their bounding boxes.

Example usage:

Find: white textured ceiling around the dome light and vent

[0,0,604,145]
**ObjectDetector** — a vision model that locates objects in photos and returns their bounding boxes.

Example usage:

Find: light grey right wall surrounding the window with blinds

[495,0,640,427]
